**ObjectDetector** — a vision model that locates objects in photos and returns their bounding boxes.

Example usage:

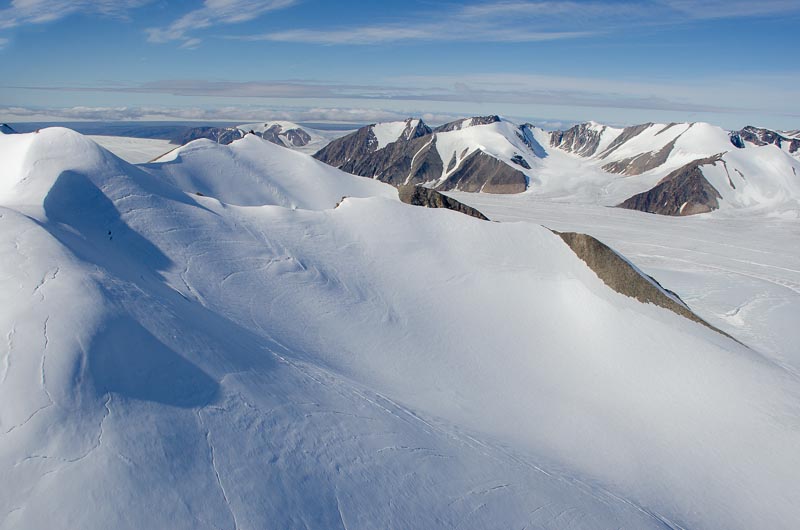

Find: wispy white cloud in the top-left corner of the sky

[0,0,153,29]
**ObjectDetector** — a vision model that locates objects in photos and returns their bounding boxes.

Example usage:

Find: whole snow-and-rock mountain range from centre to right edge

[304,116,800,215]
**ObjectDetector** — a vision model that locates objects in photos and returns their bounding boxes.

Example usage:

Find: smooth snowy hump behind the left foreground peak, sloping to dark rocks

[147,135,397,210]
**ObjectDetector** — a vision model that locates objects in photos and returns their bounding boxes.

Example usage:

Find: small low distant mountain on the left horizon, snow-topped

[173,121,349,154]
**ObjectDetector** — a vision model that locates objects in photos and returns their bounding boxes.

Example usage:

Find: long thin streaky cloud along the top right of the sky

[228,0,800,45]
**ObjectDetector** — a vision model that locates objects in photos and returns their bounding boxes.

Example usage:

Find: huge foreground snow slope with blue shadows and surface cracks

[0,129,800,529]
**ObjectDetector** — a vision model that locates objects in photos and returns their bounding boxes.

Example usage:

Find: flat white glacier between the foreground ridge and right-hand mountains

[448,193,800,374]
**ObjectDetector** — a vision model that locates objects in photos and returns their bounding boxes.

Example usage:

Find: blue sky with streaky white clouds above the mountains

[0,0,800,129]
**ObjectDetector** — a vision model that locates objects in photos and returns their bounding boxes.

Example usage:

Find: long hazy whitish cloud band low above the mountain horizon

[13,72,800,115]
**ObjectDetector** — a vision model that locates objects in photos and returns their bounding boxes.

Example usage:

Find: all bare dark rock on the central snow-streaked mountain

[314,116,541,193]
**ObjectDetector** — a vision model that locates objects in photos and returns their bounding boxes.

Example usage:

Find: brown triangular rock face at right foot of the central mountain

[437,150,528,193]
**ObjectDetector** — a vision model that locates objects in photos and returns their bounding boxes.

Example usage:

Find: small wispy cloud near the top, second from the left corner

[146,0,298,48]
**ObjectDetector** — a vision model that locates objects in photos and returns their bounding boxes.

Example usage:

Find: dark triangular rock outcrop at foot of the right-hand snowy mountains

[617,155,722,215]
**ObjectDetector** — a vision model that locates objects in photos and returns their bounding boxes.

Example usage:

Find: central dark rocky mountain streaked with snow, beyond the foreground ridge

[314,116,543,193]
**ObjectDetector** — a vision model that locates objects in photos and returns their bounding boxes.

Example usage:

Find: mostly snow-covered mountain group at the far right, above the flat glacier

[550,123,800,215]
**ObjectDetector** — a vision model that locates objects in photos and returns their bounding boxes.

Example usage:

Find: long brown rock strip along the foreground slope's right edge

[554,232,735,340]
